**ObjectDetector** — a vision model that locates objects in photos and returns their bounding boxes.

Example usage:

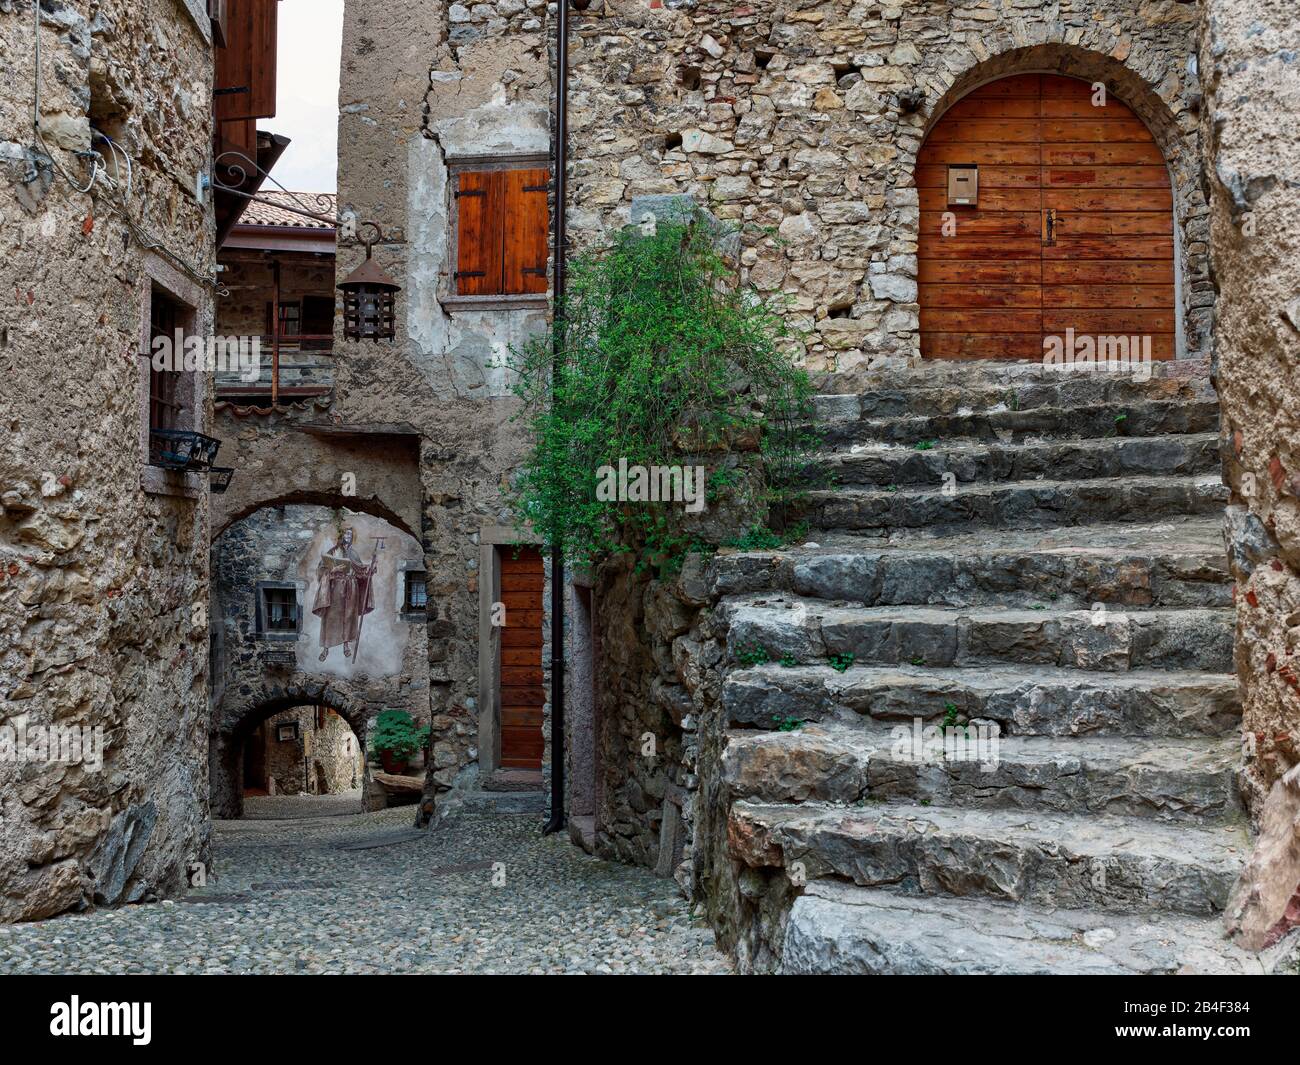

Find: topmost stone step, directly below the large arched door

[813,362,1213,423]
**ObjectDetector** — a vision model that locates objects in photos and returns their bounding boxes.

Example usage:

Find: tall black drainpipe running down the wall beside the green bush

[542,0,569,836]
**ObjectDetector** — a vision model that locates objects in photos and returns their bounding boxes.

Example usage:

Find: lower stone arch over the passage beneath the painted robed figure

[208,681,384,819]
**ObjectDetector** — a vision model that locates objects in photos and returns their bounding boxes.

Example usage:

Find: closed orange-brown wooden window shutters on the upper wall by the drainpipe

[454,169,550,295]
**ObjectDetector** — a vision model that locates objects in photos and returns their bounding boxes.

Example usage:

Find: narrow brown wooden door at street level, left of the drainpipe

[499,547,546,770]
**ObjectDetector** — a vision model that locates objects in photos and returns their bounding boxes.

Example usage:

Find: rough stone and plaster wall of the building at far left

[0,0,213,921]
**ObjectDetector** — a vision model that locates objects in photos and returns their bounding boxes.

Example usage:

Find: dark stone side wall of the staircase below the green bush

[595,550,769,967]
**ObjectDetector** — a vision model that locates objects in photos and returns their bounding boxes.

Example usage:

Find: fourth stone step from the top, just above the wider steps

[803,473,1229,533]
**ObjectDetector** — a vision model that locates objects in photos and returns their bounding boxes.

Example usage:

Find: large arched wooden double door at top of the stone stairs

[917,74,1175,359]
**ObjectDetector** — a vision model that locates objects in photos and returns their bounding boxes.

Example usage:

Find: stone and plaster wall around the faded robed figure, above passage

[211,505,430,817]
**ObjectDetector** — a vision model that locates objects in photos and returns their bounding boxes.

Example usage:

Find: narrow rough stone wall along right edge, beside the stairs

[1201,0,1300,811]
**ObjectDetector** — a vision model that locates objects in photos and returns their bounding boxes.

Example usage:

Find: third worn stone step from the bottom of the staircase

[723,722,1242,821]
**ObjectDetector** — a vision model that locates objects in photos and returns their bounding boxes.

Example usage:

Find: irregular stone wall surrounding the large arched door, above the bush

[569,0,1213,372]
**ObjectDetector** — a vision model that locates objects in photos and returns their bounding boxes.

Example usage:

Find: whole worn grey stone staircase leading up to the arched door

[715,364,1289,974]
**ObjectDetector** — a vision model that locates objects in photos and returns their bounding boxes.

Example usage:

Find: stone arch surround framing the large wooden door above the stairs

[907,42,1213,358]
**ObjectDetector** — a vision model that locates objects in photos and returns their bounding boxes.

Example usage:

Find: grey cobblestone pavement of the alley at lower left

[0,808,731,973]
